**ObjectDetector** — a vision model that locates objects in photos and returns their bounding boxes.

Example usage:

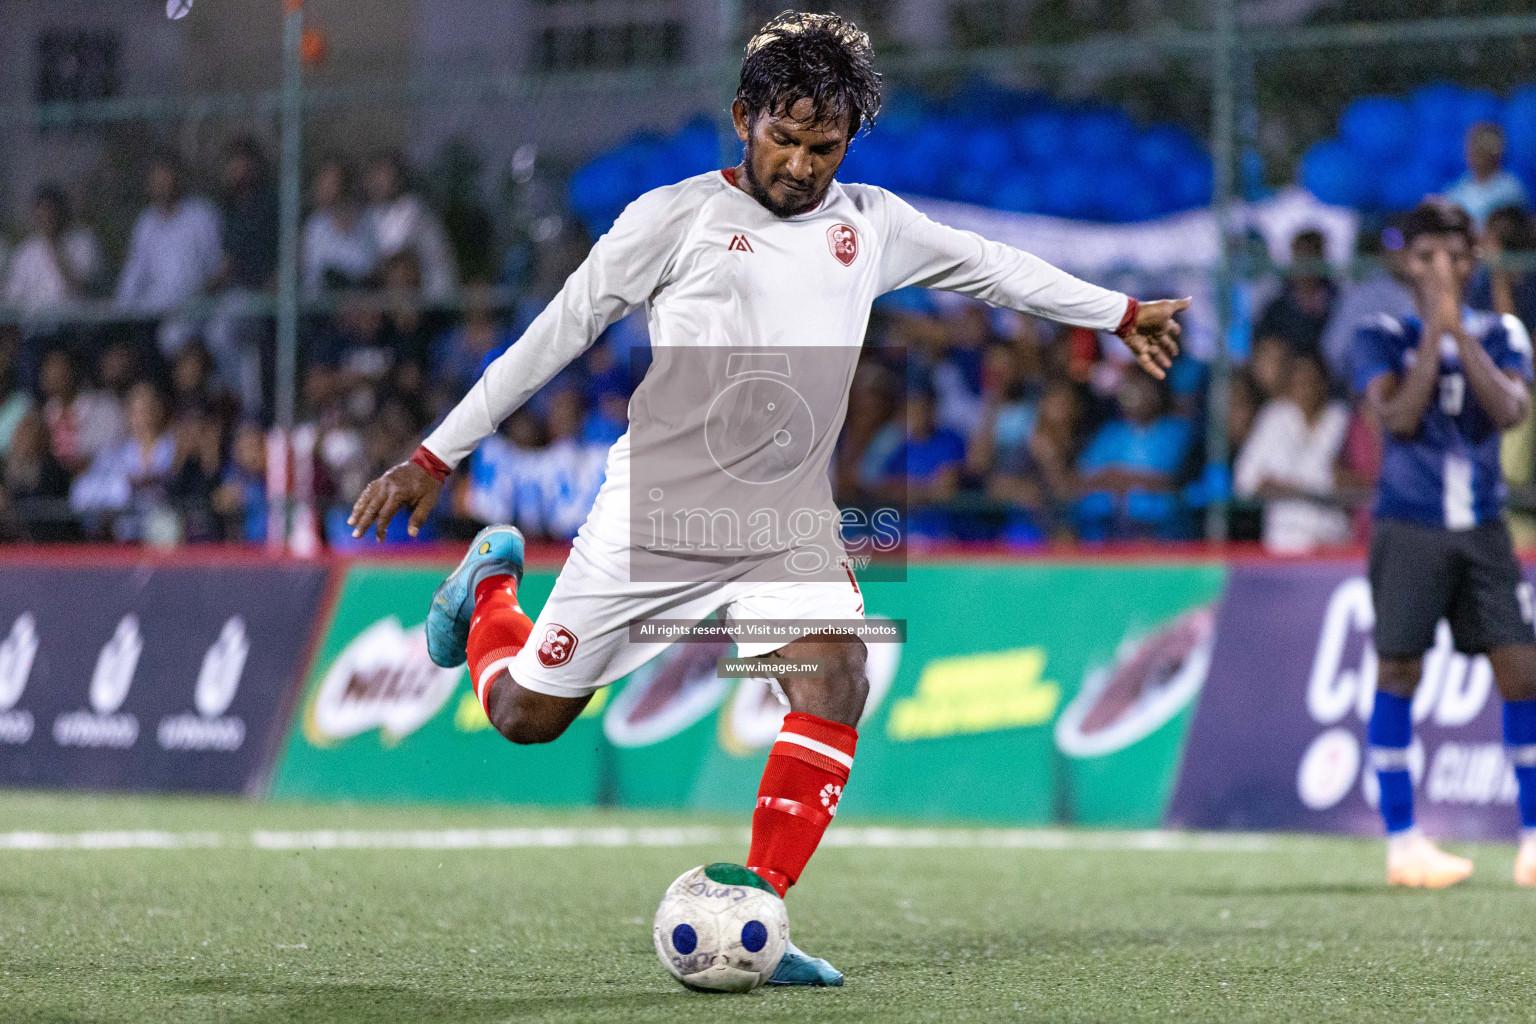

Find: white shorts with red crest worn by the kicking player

[497,540,863,697]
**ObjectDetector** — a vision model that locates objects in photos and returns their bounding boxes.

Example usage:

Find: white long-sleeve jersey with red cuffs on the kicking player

[424,172,1129,564]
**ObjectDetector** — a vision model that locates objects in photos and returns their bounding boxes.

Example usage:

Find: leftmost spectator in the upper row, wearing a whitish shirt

[3,184,101,313]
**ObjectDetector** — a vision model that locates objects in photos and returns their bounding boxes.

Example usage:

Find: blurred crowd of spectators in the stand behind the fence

[0,124,1536,551]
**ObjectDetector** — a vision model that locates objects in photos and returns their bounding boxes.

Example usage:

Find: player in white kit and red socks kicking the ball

[349,12,1189,984]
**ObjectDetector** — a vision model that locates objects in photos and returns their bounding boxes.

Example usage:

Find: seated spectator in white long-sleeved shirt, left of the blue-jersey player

[1233,352,1350,554]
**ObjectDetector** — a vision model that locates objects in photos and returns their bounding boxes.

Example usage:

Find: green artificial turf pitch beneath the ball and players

[0,794,1536,1024]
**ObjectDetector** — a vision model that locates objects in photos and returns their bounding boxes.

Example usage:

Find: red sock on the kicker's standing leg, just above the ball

[746,711,859,897]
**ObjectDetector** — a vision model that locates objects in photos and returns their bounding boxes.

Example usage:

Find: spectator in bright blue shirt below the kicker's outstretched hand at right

[1075,367,1192,540]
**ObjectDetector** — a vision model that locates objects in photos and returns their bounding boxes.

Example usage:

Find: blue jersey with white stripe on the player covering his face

[1353,310,1531,530]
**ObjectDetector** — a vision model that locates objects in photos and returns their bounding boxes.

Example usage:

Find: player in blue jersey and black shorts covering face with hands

[1355,200,1536,887]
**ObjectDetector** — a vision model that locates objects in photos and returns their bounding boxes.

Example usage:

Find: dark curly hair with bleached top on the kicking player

[736,11,880,140]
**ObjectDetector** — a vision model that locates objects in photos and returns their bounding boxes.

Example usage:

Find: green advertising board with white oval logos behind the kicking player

[273,560,1226,826]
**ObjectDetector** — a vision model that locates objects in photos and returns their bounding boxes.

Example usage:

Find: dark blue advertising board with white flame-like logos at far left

[0,562,326,794]
